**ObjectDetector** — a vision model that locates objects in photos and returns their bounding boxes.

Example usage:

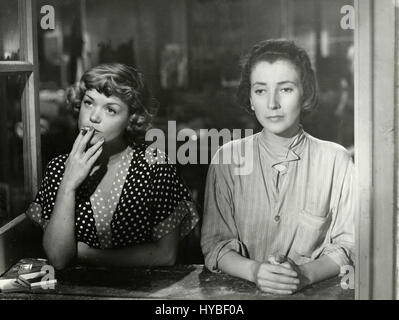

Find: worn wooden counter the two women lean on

[0,265,354,300]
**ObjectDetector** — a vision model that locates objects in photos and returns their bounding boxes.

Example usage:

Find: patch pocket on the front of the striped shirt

[293,210,330,257]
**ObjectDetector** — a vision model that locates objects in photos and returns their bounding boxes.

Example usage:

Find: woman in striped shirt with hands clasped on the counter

[201,40,355,294]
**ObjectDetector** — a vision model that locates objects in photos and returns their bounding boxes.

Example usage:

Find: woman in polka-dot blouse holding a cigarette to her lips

[26,64,198,269]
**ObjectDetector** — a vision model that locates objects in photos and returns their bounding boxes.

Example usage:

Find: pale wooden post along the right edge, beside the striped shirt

[355,0,398,299]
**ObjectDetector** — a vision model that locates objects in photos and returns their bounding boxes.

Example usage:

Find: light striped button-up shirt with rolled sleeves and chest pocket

[201,129,355,271]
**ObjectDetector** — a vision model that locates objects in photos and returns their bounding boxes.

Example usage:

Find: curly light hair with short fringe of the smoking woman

[67,63,158,145]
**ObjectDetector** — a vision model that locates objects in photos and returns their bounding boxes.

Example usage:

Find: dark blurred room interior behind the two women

[0,0,354,262]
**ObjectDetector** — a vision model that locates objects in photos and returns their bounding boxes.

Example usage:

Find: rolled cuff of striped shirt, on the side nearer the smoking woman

[205,239,249,273]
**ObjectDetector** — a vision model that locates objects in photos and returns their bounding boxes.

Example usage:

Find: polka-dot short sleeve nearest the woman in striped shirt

[151,164,199,241]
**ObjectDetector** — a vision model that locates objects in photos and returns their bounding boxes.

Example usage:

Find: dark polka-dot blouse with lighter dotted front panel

[26,145,199,249]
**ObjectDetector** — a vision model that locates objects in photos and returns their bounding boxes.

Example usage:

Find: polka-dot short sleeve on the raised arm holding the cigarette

[25,155,67,229]
